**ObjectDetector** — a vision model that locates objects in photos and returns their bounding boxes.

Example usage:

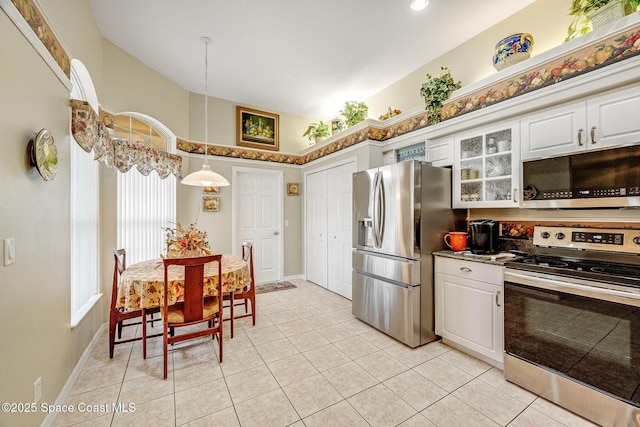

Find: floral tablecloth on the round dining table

[118,255,251,311]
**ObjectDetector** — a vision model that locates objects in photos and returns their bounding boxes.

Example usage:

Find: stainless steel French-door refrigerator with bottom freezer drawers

[352,160,465,347]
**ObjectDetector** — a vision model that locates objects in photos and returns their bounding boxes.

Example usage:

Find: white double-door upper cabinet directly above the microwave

[521,85,640,160]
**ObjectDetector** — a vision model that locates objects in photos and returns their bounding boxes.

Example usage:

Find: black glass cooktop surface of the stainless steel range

[505,255,640,288]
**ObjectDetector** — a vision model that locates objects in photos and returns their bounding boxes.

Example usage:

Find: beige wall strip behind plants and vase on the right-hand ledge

[366,0,571,117]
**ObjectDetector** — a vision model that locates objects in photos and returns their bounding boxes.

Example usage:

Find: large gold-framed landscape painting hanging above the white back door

[236,105,280,151]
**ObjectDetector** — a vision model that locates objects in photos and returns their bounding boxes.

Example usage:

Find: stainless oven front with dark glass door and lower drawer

[504,268,640,424]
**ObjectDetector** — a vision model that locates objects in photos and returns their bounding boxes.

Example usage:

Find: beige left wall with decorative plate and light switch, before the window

[0,12,75,426]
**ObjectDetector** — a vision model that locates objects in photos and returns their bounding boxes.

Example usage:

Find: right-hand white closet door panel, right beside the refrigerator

[327,162,356,299]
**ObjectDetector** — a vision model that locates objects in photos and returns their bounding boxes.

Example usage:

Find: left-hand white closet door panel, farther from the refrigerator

[304,170,327,288]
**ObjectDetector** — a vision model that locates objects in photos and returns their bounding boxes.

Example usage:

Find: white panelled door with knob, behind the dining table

[233,168,284,283]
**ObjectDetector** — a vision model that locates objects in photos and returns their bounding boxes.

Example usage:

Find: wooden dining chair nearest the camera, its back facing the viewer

[162,255,223,379]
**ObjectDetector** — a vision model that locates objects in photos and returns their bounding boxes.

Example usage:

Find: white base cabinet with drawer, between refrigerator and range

[435,256,504,367]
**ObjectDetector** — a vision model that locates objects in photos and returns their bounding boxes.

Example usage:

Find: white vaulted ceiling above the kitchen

[90,0,534,119]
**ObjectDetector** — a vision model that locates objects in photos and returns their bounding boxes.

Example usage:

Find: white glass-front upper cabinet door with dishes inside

[453,123,520,208]
